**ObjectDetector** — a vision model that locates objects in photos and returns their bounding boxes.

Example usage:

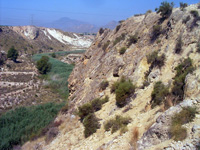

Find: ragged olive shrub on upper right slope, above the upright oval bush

[147,51,165,69]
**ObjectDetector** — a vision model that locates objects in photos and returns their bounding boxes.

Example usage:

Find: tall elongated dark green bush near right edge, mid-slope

[172,58,194,101]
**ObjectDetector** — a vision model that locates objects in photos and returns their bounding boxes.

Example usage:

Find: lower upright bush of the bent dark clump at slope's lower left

[83,114,100,138]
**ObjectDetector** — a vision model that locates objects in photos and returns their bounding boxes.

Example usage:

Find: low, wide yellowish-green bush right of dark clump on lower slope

[104,115,131,133]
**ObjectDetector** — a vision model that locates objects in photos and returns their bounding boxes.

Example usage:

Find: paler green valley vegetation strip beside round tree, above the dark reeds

[32,50,79,99]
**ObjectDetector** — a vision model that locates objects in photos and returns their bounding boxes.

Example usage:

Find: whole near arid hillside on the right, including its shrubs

[22,4,200,150]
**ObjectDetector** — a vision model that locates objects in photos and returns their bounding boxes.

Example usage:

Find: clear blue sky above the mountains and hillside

[0,0,199,25]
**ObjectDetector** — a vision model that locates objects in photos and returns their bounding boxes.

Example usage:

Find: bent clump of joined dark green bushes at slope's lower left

[77,96,109,138]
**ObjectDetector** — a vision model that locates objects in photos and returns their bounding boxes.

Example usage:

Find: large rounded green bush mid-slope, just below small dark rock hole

[115,80,135,107]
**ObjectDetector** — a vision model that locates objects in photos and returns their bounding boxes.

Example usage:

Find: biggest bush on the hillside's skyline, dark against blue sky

[155,1,174,19]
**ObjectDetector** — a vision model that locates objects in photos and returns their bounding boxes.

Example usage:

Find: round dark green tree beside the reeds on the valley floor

[36,56,51,74]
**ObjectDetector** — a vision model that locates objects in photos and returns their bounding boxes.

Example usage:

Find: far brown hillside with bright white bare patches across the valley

[0,26,93,54]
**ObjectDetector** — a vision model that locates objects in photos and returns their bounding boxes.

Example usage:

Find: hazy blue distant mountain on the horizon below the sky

[37,17,117,33]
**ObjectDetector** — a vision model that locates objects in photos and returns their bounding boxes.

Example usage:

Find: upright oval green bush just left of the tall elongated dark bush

[151,81,169,108]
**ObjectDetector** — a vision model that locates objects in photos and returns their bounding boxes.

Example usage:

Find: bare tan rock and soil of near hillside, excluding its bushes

[22,5,200,150]
